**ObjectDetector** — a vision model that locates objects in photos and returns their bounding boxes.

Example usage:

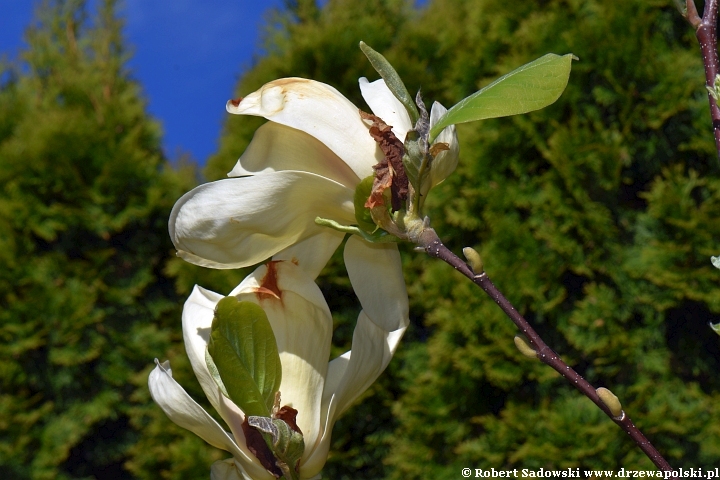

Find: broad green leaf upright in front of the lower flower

[207,297,282,417]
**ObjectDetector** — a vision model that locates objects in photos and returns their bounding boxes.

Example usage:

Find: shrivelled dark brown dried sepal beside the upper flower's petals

[360,110,408,212]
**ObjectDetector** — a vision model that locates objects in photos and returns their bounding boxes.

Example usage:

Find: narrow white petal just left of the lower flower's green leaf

[182,285,227,412]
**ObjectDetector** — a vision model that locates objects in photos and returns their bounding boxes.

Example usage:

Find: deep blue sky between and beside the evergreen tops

[0,0,282,164]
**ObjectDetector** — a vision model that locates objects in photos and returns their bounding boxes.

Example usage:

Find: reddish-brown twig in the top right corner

[685,0,720,157]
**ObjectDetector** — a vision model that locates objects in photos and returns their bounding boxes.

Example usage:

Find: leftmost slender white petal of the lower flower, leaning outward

[148,360,243,457]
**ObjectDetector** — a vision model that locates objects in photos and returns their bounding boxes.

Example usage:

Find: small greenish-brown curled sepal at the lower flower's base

[248,416,305,478]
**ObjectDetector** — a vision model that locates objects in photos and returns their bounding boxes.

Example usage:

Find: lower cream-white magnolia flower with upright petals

[149,253,409,480]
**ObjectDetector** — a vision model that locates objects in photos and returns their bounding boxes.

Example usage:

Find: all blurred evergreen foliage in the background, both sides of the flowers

[0,0,720,479]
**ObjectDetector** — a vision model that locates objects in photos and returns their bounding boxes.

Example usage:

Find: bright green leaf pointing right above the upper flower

[430,53,577,141]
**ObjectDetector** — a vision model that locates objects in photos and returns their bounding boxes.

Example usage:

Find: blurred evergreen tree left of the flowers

[0,0,222,479]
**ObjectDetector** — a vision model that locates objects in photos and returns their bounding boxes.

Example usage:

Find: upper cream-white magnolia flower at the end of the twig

[170,78,458,278]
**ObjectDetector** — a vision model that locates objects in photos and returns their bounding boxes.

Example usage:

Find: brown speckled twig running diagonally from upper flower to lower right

[419,228,673,472]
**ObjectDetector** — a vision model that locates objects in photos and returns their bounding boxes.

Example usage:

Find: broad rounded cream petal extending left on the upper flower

[169,171,355,268]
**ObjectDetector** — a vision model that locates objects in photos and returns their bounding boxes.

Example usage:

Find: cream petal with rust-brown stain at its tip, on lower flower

[232,261,333,462]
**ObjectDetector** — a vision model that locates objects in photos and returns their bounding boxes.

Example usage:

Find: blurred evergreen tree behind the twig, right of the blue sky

[207,0,720,479]
